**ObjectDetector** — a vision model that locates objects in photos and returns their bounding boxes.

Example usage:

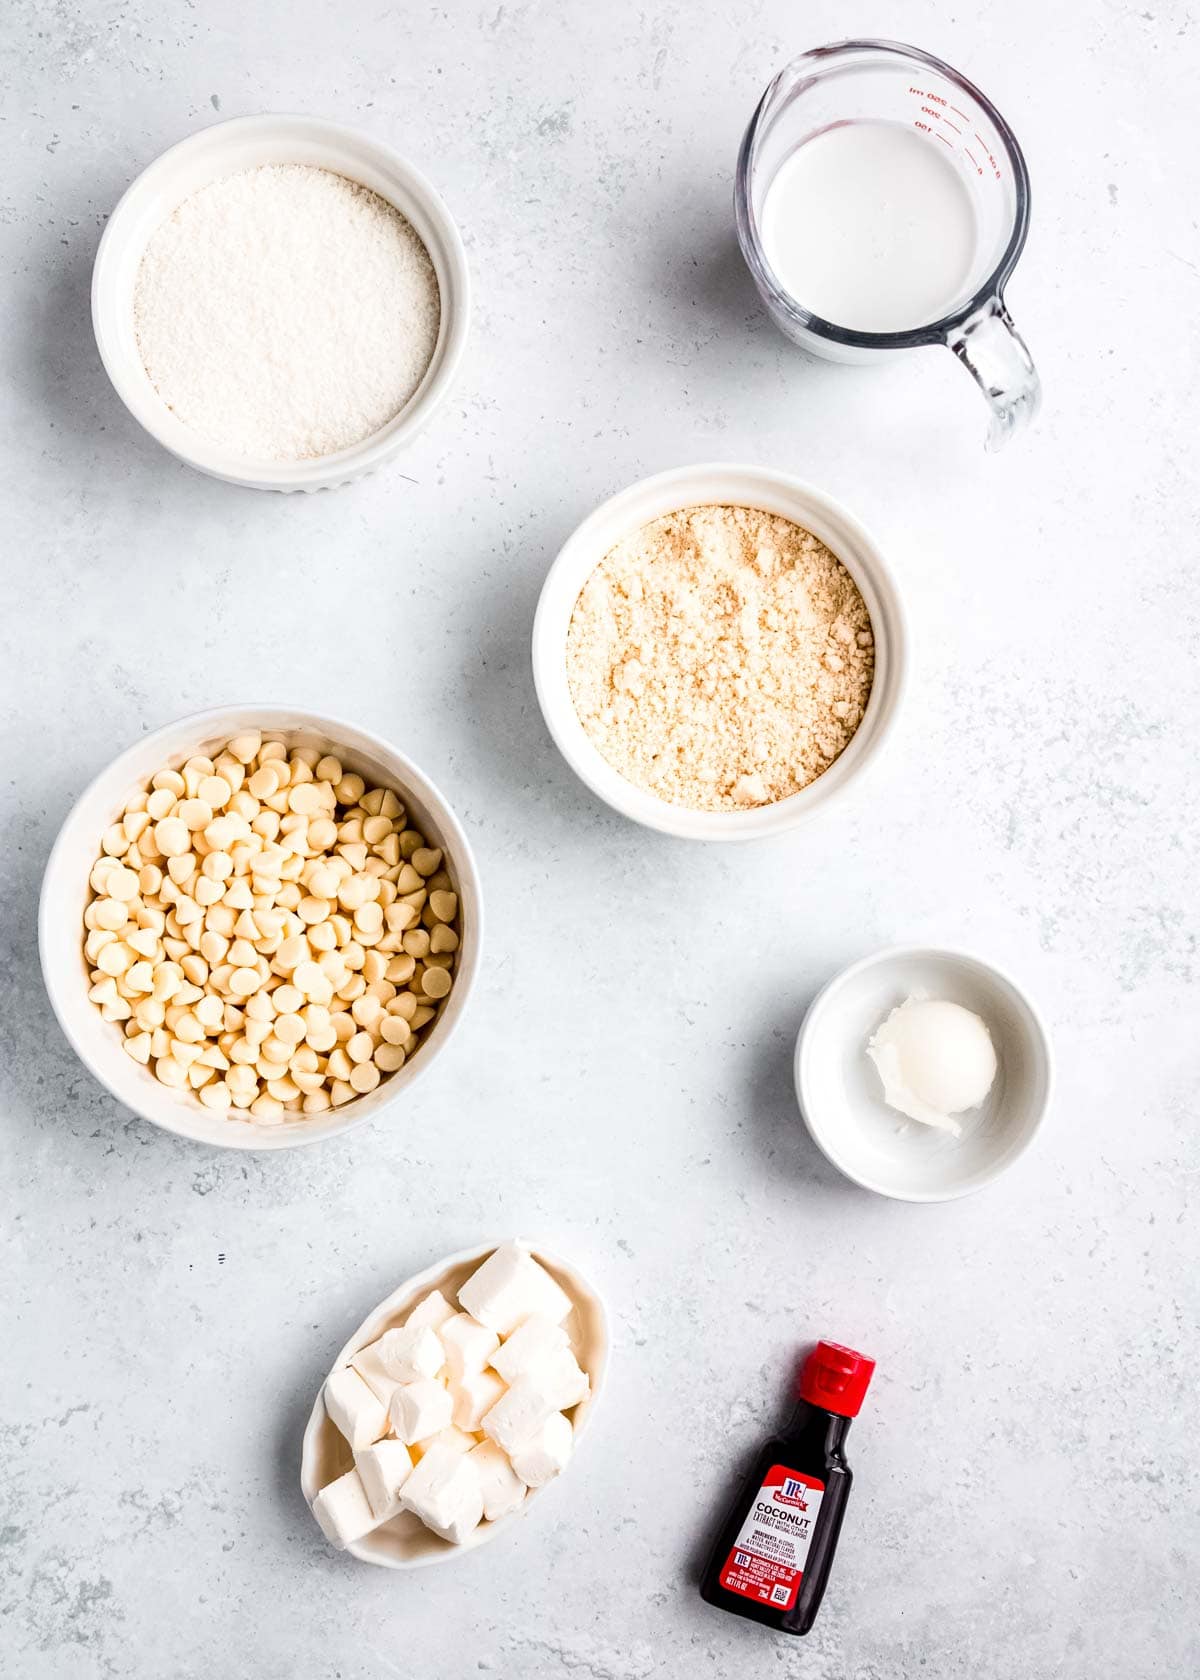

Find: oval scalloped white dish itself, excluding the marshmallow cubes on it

[301,1243,608,1569]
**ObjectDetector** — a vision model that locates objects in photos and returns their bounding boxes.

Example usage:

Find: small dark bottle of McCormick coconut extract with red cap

[701,1342,876,1633]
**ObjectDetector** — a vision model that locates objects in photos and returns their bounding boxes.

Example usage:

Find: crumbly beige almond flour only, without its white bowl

[566,506,874,811]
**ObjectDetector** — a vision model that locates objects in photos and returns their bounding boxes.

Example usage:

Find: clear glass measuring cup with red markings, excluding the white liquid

[734,40,1040,449]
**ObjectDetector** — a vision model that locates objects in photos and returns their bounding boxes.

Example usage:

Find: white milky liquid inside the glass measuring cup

[761,121,976,333]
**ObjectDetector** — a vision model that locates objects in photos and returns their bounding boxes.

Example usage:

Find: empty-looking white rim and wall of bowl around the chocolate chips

[37,706,482,1149]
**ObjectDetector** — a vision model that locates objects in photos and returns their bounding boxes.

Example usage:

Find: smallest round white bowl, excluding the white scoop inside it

[795,946,1052,1201]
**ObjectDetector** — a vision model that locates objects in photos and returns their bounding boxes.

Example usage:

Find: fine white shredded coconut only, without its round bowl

[133,163,440,460]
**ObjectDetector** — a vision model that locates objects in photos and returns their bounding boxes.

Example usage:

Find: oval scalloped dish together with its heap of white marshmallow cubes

[301,1242,608,1569]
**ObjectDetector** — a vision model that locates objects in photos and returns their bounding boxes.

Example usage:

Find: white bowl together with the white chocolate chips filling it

[39,706,482,1149]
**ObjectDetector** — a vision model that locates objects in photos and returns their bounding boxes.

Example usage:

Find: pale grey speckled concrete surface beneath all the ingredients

[0,0,1200,1680]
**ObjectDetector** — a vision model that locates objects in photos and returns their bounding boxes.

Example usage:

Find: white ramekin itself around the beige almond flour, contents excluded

[533,462,906,840]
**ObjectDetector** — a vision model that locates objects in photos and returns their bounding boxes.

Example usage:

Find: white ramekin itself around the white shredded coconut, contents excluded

[92,116,471,491]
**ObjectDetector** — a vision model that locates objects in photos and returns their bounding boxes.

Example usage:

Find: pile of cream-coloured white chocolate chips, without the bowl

[84,731,459,1126]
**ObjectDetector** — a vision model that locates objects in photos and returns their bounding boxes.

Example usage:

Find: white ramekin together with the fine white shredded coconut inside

[92,116,471,491]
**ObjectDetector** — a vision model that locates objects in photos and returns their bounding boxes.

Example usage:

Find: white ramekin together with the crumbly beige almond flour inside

[533,465,906,840]
